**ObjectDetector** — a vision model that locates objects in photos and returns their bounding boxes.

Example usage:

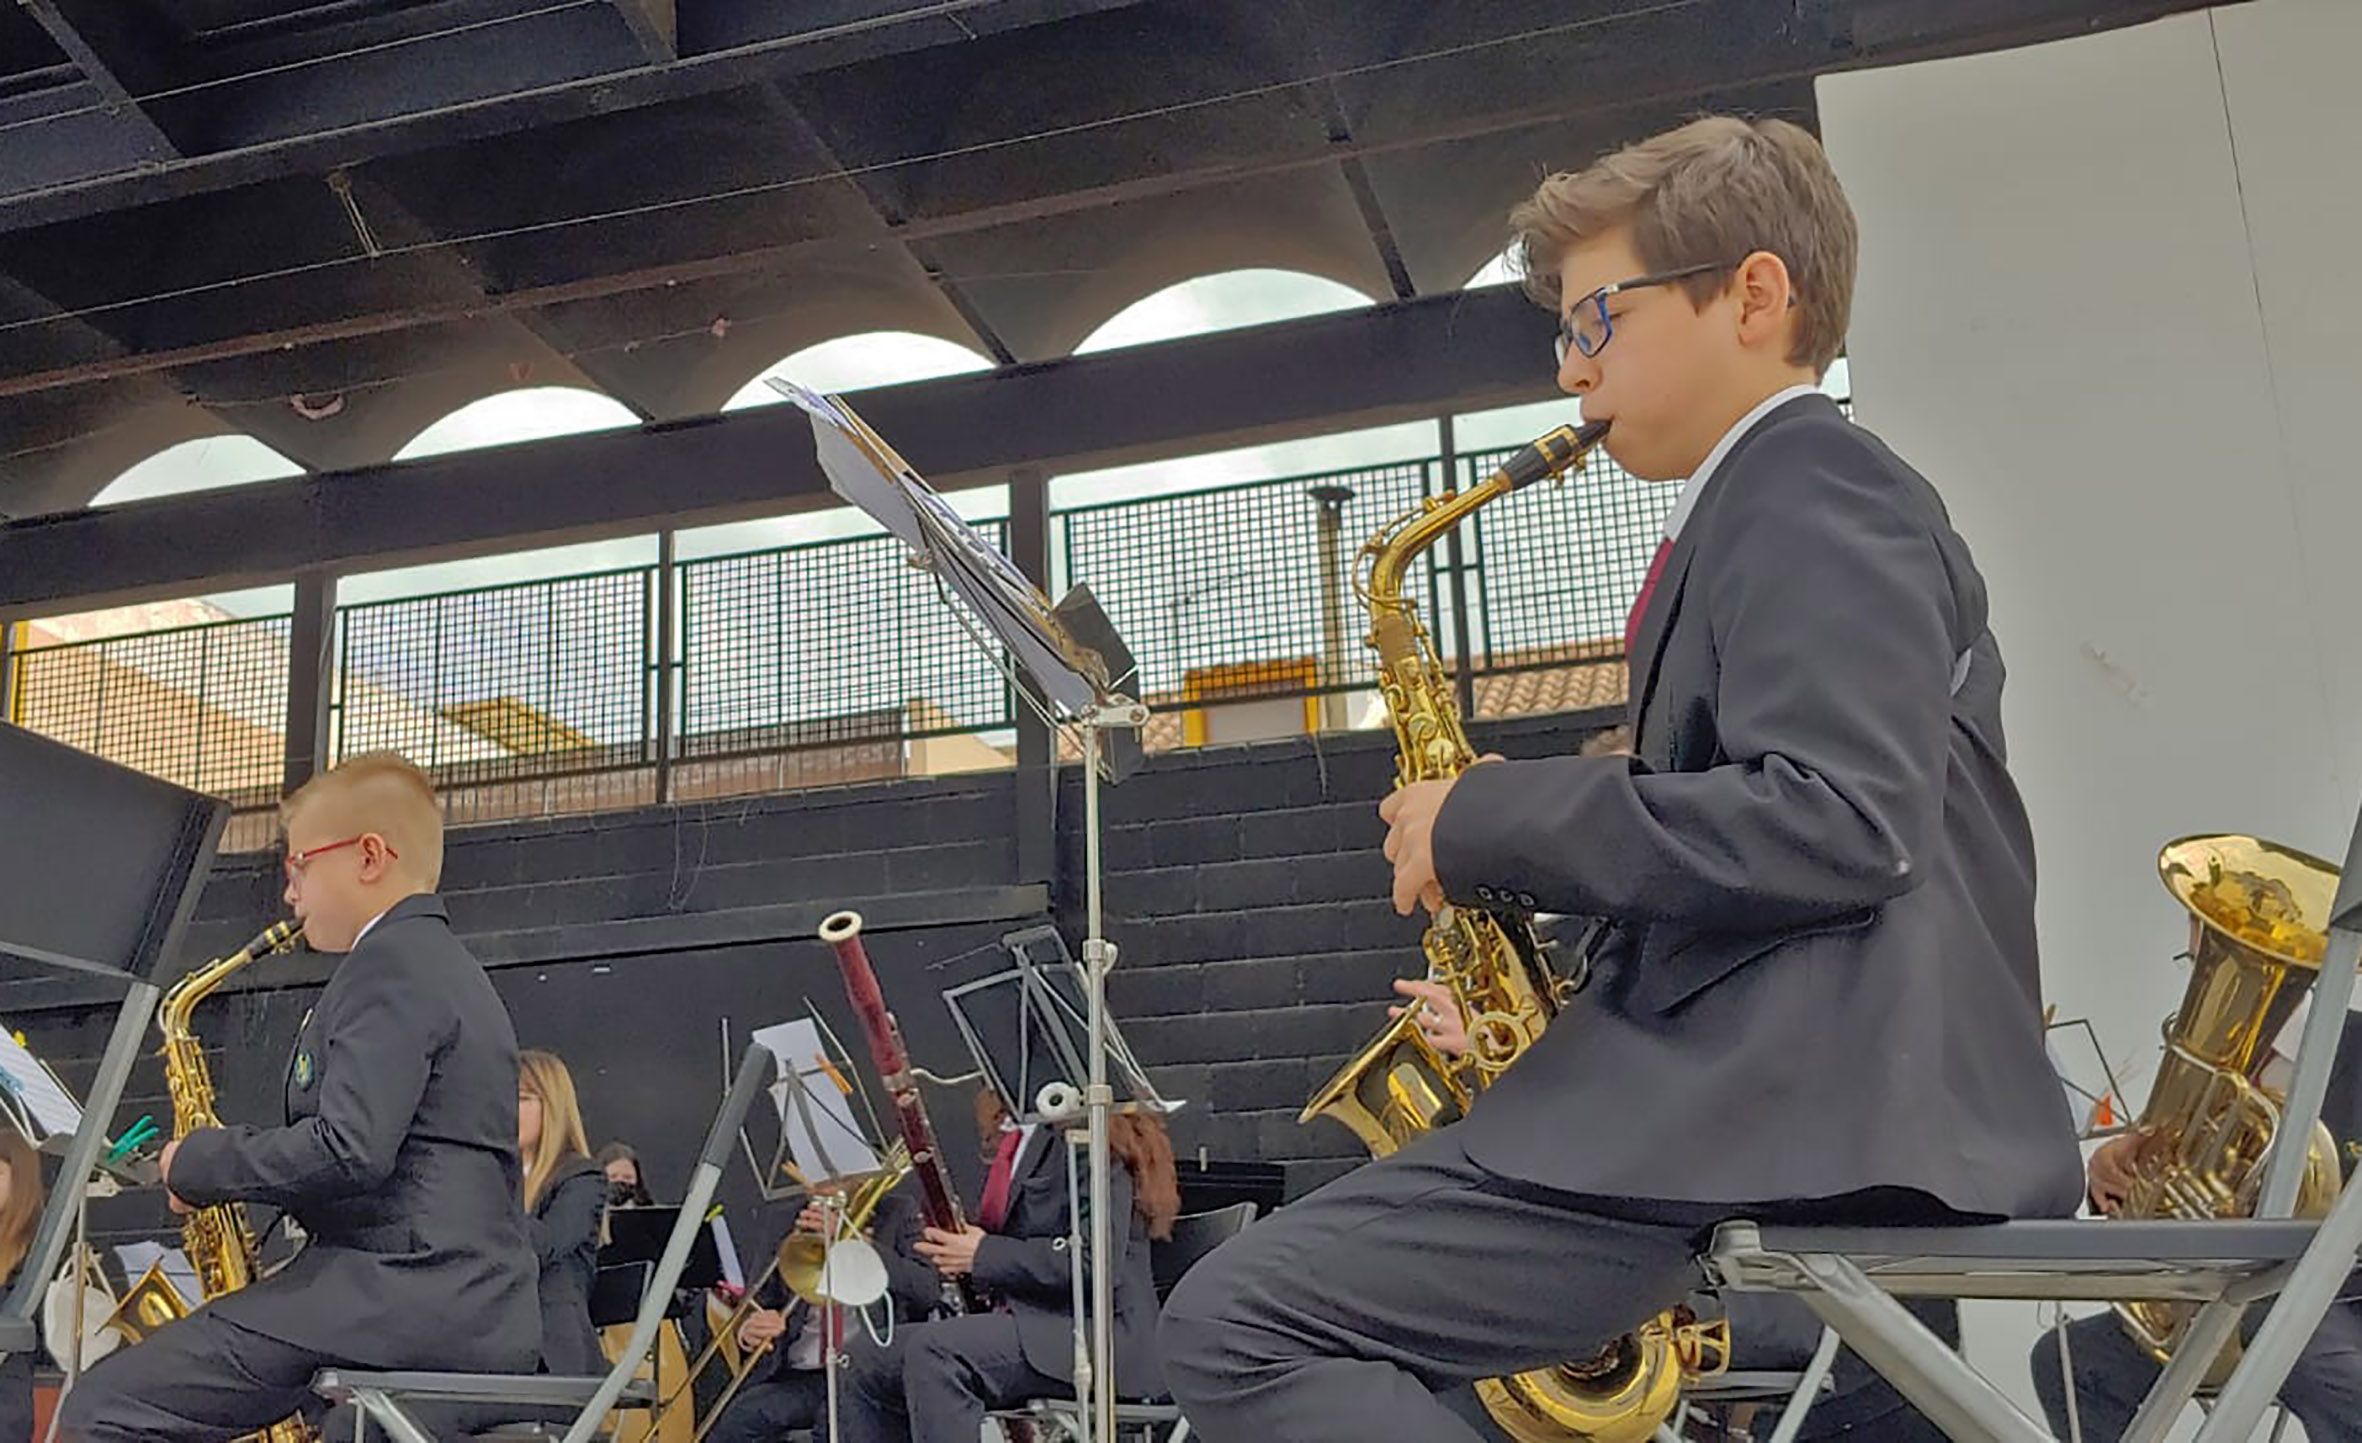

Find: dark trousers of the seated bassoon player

[836,1313,1072,1443]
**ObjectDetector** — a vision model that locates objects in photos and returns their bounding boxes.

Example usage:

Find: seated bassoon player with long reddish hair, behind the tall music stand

[841,1091,1181,1443]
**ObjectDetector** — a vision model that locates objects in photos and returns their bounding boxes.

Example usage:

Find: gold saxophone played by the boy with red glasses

[106,921,319,1443]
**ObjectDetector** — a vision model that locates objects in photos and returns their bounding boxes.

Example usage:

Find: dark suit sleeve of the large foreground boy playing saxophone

[1434,427,1972,931]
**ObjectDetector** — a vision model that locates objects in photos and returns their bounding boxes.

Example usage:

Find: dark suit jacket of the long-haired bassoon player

[976,1127,1164,1398]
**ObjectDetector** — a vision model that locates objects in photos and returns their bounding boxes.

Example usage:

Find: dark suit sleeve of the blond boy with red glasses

[170,947,458,1209]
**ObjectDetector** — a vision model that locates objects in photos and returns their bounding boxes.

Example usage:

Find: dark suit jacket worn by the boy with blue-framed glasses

[1434,397,2083,1219]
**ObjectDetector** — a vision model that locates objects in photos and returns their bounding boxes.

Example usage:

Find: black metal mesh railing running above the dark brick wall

[0,422,1719,836]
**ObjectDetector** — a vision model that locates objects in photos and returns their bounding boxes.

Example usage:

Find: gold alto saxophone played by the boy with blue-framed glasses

[1297,423,1729,1443]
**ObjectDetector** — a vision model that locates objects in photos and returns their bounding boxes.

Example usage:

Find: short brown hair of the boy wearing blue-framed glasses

[1509,116,1859,376]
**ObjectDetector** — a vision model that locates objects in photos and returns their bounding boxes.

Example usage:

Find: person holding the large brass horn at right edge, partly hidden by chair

[2031,997,2362,1443]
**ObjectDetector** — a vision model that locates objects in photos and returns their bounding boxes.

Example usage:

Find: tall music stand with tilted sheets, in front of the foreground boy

[768,378,1148,1443]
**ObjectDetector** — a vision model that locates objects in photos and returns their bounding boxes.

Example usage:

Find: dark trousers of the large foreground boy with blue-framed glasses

[1157,1129,1701,1443]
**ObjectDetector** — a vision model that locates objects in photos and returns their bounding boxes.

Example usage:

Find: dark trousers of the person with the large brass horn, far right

[2034,1301,2362,1443]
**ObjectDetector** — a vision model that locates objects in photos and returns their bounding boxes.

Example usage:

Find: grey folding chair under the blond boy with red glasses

[312,1046,777,1443]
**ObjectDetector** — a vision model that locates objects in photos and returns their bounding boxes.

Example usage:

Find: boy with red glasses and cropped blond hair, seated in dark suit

[61,753,541,1443]
